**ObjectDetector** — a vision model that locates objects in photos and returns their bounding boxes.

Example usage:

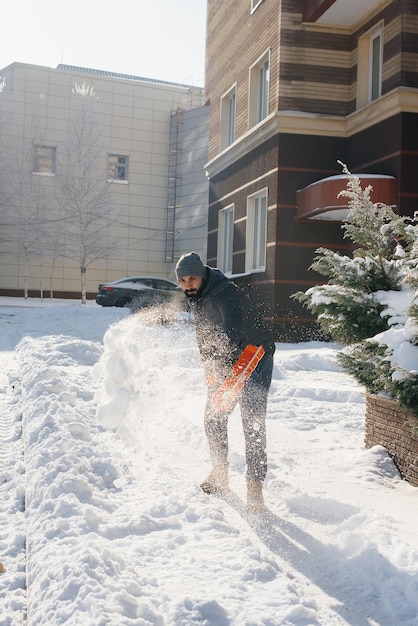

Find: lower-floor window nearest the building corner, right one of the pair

[245,189,267,272]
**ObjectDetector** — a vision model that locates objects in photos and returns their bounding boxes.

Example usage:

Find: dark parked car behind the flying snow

[96,276,181,309]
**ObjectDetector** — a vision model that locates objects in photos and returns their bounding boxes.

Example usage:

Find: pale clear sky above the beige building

[0,0,206,87]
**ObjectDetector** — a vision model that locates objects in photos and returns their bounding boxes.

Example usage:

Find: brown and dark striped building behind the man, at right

[206,0,418,340]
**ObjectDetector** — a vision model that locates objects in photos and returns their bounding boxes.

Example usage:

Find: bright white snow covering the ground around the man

[0,298,418,626]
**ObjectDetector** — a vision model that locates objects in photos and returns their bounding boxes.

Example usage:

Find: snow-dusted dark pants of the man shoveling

[205,356,273,481]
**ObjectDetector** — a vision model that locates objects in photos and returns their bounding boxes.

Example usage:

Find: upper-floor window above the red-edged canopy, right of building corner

[357,22,383,108]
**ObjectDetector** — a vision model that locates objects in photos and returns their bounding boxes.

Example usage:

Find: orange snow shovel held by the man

[212,344,264,413]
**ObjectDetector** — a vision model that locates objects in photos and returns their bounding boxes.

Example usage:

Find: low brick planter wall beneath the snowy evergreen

[365,394,418,487]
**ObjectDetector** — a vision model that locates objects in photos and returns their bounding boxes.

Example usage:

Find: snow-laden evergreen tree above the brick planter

[294,165,418,416]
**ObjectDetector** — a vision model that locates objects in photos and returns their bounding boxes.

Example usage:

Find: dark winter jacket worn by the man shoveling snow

[190,266,275,371]
